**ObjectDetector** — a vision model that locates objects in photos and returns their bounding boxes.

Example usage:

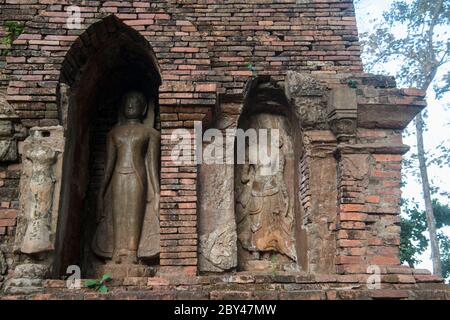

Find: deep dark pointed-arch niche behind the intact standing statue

[54,15,161,276]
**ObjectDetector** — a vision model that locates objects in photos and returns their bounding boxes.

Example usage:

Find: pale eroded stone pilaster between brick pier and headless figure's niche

[198,101,242,272]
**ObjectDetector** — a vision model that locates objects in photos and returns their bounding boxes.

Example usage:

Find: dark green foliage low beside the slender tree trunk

[400,200,450,278]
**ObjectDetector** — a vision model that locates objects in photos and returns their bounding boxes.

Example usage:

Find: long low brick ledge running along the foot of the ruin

[0,272,450,300]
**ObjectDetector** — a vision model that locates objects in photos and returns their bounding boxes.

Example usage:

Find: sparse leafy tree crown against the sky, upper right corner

[362,0,450,95]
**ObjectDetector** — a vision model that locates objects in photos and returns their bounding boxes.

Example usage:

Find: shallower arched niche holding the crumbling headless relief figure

[234,78,307,271]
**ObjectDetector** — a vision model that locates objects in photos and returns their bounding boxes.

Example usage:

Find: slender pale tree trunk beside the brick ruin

[415,113,442,277]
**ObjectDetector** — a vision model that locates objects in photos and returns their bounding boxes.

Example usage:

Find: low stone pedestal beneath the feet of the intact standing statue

[95,263,157,279]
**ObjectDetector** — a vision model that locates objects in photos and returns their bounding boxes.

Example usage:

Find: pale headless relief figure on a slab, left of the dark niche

[6,126,65,293]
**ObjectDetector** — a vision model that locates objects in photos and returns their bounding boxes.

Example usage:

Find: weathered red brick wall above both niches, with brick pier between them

[1,0,361,276]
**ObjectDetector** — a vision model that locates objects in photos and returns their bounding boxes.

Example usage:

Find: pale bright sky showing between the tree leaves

[356,0,450,270]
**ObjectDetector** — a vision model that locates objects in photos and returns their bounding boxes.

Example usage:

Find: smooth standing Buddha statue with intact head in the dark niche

[92,91,160,264]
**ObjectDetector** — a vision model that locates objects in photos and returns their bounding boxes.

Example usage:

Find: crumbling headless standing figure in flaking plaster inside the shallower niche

[236,114,297,270]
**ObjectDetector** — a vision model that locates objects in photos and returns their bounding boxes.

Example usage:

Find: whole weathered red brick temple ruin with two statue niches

[0,0,450,299]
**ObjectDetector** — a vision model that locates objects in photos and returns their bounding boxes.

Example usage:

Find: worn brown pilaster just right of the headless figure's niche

[301,130,337,273]
